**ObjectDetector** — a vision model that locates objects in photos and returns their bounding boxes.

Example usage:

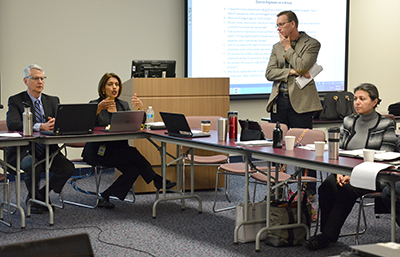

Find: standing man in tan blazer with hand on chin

[265,11,322,129]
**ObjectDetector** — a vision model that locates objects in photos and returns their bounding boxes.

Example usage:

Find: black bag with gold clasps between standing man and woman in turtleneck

[319,91,356,120]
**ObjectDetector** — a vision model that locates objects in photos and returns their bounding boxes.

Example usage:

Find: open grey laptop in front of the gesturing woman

[104,111,146,132]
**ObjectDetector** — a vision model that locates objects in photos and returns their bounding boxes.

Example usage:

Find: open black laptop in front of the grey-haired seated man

[40,103,97,136]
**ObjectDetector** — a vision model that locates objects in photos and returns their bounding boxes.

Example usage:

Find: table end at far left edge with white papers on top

[0,131,32,228]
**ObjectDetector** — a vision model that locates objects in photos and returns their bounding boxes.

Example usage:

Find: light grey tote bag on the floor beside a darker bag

[235,201,267,243]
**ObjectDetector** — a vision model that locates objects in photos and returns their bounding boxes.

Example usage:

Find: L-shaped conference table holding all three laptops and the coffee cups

[28,128,400,250]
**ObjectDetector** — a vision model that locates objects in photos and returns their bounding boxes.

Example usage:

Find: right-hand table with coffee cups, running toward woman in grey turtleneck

[146,130,400,250]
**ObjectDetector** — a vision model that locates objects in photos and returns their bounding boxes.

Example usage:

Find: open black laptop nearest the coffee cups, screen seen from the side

[160,112,210,137]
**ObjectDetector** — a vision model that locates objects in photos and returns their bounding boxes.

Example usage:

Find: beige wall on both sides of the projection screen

[0,0,400,140]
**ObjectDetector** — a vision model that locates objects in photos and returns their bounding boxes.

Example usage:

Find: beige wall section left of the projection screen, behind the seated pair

[0,0,184,111]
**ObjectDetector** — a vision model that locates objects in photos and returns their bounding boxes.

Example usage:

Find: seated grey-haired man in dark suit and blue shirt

[7,64,75,213]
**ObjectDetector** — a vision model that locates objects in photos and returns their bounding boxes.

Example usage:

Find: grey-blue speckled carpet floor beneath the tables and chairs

[0,170,400,257]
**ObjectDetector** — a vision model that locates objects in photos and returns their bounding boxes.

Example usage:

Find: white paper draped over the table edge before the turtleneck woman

[350,162,395,191]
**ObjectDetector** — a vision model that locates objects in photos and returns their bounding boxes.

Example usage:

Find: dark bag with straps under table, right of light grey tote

[265,188,311,247]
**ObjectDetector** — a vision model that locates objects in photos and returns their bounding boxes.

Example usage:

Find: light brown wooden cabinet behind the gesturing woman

[120,78,229,193]
